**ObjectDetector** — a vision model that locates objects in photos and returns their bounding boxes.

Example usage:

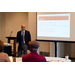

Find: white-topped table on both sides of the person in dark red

[9,56,71,62]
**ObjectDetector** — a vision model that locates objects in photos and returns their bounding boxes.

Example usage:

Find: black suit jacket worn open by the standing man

[17,30,31,48]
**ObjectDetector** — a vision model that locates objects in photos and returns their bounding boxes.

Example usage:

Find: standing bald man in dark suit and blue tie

[17,24,31,57]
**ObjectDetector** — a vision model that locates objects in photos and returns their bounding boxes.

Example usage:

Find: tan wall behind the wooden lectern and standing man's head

[1,12,28,42]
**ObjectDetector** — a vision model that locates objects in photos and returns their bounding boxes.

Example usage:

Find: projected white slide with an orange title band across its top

[37,14,70,38]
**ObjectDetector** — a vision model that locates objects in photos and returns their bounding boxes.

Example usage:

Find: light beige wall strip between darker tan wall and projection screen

[28,12,36,40]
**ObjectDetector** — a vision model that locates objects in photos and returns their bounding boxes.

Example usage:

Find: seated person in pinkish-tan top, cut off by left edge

[0,40,10,62]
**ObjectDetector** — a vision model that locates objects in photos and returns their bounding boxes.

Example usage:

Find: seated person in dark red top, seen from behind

[22,41,46,62]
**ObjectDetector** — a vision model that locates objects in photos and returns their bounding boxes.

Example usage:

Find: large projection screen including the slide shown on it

[37,12,75,42]
